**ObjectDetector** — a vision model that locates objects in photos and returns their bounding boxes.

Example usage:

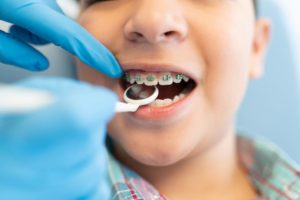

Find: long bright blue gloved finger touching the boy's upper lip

[6,4,122,77]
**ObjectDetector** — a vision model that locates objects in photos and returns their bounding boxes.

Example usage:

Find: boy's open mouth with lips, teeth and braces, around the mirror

[120,64,197,120]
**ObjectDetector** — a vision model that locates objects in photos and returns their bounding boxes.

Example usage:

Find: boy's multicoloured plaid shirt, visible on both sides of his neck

[109,136,300,200]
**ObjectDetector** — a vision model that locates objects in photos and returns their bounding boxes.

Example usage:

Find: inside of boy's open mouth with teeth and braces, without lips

[121,70,196,107]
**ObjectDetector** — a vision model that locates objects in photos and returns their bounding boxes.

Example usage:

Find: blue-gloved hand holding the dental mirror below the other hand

[0,78,117,200]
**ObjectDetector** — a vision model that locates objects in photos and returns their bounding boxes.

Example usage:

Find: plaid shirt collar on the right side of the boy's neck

[238,136,300,199]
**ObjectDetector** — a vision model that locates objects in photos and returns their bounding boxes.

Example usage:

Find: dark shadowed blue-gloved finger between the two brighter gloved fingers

[9,25,49,45]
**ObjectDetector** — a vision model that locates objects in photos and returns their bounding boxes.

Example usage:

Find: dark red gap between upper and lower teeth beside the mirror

[157,84,184,100]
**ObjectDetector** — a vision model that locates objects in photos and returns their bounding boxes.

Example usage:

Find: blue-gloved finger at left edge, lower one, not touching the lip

[0,31,49,71]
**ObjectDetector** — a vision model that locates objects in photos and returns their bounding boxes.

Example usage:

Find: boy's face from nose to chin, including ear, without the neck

[78,0,269,166]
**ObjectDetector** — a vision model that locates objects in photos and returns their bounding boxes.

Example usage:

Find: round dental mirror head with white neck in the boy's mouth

[115,84,159,112]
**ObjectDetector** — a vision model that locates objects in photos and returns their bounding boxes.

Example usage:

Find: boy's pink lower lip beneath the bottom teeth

[119,86,196,121]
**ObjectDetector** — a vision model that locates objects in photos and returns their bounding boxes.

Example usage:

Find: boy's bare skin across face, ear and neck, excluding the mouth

[77,0,270,200]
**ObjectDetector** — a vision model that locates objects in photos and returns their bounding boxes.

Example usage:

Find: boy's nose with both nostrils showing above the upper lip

[124,0,188,44]
